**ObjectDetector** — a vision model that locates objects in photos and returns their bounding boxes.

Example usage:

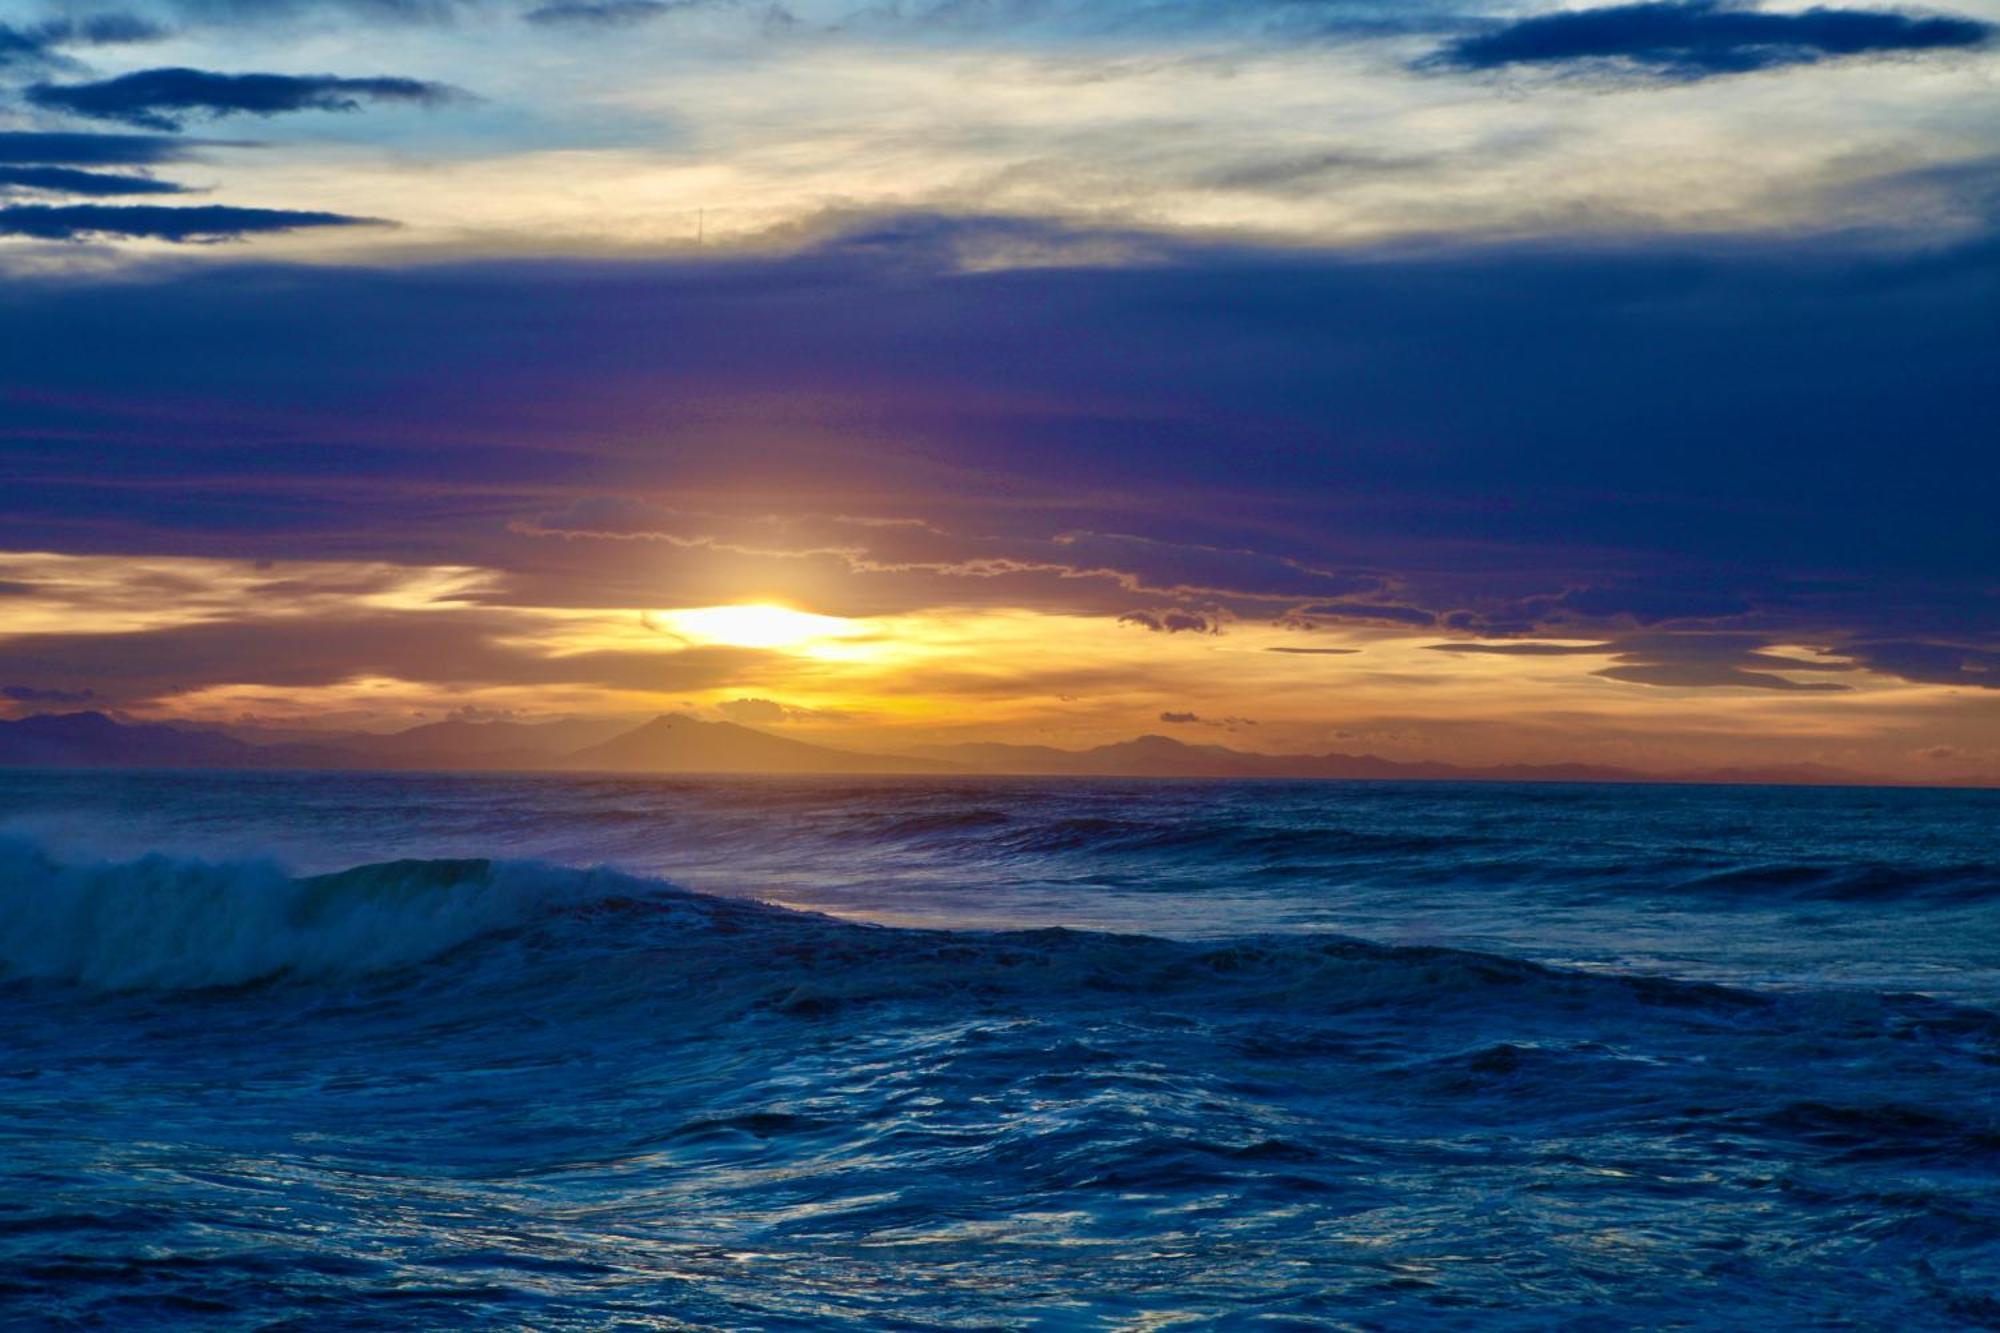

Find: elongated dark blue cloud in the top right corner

[1434,0,1994,78]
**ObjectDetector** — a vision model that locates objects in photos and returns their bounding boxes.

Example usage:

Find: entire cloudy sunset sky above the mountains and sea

[0,0,2000,783]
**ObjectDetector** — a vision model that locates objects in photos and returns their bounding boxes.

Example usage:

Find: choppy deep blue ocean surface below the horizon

[0,773,2000,1331]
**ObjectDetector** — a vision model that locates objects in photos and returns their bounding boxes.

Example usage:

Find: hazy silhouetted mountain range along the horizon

[0,713,1904,785]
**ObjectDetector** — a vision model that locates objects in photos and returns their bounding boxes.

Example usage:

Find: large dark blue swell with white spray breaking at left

[0,841,2000,1059]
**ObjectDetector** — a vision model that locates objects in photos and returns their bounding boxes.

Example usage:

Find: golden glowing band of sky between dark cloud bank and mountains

[0,552,2000,779]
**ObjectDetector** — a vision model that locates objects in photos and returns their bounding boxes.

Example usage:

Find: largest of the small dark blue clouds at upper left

[26,68,464,130]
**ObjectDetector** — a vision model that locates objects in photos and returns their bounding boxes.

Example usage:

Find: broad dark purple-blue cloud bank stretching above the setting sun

[0,220,2000,689]
